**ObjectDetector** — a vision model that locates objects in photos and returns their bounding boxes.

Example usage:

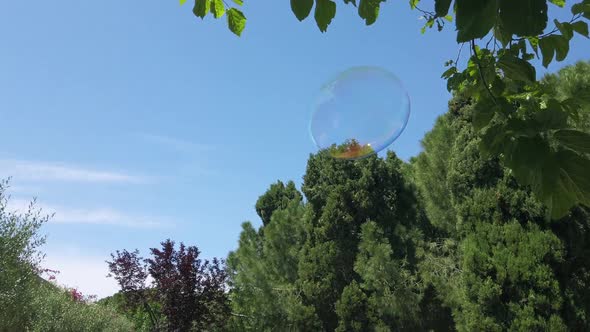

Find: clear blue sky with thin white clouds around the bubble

[0,0,590,296]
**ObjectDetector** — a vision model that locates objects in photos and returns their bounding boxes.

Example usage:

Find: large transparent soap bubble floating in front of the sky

[310,67,410,159]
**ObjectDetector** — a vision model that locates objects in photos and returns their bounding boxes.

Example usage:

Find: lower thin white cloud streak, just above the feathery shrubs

[8,199,171,228]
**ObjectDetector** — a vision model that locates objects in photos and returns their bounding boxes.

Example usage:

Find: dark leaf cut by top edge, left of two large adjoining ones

[455,0,497,43]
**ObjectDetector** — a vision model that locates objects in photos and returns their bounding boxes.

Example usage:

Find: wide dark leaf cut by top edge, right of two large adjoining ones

[499,0,547,36]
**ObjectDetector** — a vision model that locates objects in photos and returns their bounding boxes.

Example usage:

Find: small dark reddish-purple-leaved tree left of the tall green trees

[108,239,230,331]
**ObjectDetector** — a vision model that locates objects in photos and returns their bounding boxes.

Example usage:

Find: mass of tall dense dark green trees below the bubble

[228,63,590,331]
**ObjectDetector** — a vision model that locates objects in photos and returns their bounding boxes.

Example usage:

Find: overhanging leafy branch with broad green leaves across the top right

[186,0,590,219]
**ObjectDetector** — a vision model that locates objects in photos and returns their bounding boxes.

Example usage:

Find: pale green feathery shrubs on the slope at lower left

[0,181,132,332]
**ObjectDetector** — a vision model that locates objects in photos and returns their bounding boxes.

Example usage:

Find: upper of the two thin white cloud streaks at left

[0,159,146,183]
